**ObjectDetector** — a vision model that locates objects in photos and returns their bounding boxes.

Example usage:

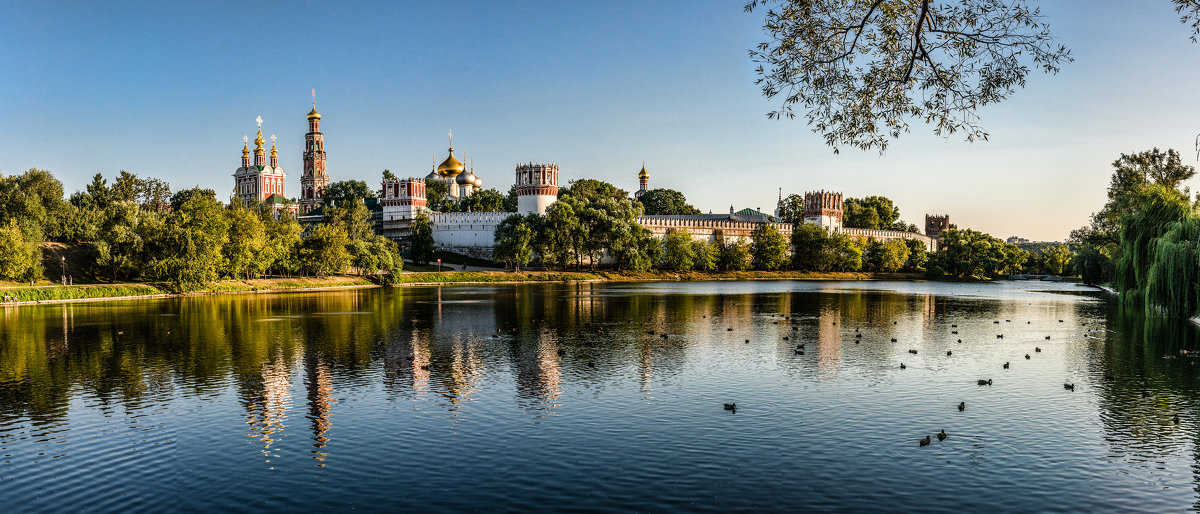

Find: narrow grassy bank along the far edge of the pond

[0,270,1041,306]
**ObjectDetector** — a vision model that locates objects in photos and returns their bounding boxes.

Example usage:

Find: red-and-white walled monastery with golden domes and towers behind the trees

[233,99,949,258]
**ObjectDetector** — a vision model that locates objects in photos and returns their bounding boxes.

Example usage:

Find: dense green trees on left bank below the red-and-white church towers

[0,169,402,291]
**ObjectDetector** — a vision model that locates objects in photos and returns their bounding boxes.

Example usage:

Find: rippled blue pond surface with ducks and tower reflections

[0,281,1200,512]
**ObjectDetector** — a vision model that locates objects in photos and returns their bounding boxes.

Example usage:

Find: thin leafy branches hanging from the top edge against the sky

[745,0,1070,153]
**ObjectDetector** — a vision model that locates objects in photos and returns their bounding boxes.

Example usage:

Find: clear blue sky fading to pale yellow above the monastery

[0,0,1200,240]
